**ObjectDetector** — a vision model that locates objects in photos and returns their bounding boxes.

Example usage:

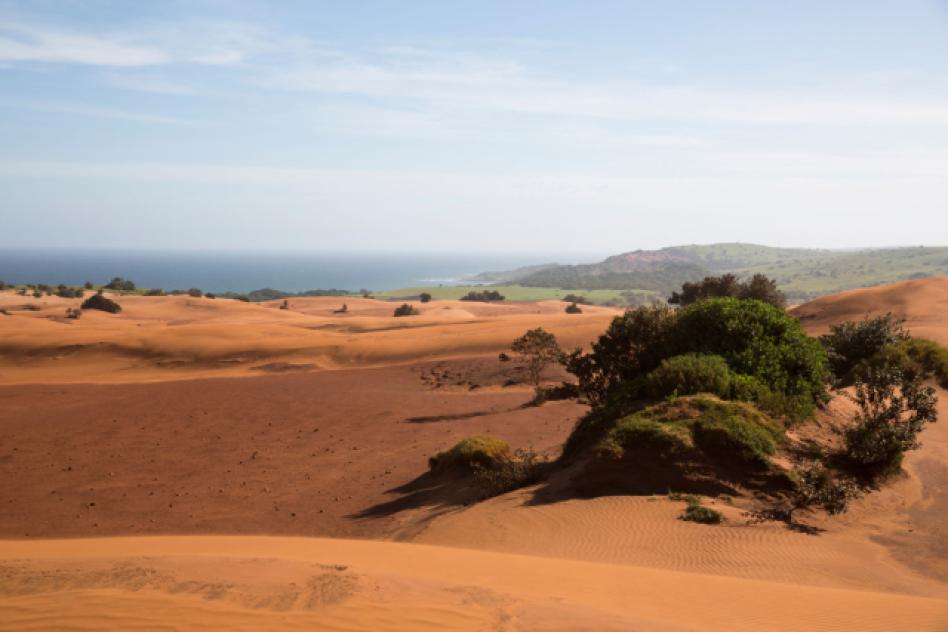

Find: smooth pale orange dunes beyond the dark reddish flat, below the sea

[0,292,617,384]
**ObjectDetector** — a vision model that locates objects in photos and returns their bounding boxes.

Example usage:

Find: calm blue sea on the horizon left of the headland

[0,250,568,292]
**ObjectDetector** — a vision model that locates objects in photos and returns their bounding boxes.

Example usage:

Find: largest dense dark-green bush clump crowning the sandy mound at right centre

[566,298,827,420]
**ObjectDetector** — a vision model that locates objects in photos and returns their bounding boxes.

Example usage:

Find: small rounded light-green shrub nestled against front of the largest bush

[645,353,731,399]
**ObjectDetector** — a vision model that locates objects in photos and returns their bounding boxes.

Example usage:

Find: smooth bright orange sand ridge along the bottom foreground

[0,537,948,632]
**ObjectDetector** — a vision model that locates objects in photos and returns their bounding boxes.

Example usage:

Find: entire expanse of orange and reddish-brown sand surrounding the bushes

[0,279,948,631]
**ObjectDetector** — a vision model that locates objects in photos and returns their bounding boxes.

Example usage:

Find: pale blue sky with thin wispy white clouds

[0,0,948,259]
